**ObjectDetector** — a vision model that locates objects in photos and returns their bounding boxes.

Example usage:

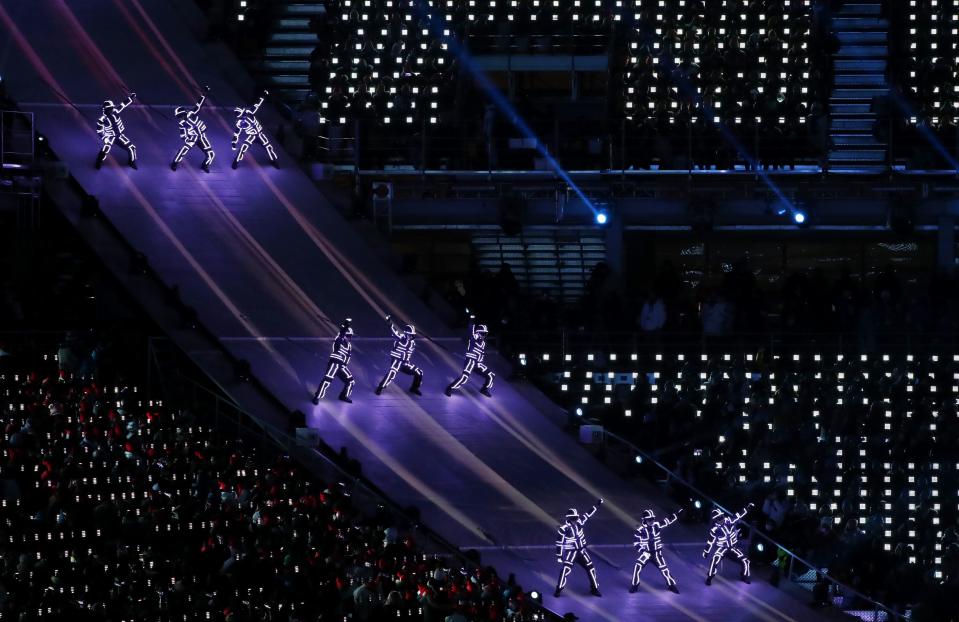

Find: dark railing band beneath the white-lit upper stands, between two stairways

[306,113,828,175]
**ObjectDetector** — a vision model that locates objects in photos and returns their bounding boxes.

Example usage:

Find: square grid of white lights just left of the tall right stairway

[621,0,815,126]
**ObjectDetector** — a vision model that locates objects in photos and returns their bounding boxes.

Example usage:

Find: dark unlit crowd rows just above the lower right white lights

[454,255,959,352]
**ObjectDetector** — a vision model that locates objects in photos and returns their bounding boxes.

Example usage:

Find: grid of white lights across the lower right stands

[552,350,959,577]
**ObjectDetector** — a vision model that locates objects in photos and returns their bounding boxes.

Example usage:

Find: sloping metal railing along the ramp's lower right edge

[603,429,909,622]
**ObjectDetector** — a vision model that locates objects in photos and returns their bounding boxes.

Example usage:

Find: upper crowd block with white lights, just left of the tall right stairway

[611,0,834,169]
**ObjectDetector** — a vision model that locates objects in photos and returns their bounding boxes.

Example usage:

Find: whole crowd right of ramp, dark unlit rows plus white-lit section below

[496,263,959,620]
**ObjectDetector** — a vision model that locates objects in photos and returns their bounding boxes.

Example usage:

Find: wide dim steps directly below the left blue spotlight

[472,231,606,302]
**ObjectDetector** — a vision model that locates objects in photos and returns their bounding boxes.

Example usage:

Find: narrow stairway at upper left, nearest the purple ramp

[258,0,326,105]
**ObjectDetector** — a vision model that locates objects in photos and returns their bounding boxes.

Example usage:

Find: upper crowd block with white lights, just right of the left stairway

[301,0,457,168]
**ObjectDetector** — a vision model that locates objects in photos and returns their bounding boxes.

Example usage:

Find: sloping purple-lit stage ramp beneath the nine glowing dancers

[0,0,836,622]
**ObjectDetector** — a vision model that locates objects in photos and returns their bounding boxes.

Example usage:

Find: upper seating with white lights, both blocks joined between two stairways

[310,0,826,139]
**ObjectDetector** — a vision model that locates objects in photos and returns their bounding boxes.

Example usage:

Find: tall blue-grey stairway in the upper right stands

[829,1,889,169]
